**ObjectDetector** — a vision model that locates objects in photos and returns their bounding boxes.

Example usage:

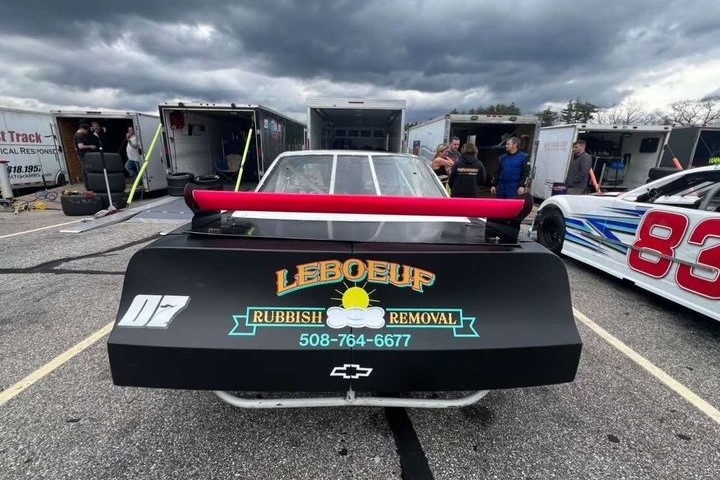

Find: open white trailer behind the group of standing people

[407,113,540,182]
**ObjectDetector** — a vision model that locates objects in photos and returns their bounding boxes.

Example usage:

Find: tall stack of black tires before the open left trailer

[85,152,128,208]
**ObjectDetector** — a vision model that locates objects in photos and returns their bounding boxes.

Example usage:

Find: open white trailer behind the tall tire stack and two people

[50,110,167,192]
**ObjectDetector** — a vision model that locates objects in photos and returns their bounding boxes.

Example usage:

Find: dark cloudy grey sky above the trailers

[0,0,720,121]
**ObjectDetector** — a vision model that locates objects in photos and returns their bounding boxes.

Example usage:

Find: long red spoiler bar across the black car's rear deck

[186,190,525,219]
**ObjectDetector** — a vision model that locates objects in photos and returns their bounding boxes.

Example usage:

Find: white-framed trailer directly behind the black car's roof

[307,98,406,153]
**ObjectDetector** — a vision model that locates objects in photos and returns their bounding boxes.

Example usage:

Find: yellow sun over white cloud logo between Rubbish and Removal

[327,282,385,329]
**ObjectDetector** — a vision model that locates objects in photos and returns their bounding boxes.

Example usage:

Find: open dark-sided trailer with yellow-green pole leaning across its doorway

[159,102,305,182]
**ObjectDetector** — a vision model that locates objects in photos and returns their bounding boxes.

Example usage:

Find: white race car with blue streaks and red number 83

[531,165,720,320]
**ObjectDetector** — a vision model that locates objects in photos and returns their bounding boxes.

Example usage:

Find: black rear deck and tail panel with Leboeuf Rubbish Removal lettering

[108,216,581,392]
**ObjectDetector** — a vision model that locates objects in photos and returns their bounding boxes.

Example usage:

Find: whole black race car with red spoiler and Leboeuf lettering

[108,150,581,407]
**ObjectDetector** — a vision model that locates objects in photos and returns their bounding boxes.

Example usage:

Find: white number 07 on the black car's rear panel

[117,295,190,328]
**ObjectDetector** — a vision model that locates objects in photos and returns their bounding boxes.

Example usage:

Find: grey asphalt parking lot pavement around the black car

[0,195,720,480]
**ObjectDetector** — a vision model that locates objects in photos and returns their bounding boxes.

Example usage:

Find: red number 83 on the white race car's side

[627,210,720,300]
